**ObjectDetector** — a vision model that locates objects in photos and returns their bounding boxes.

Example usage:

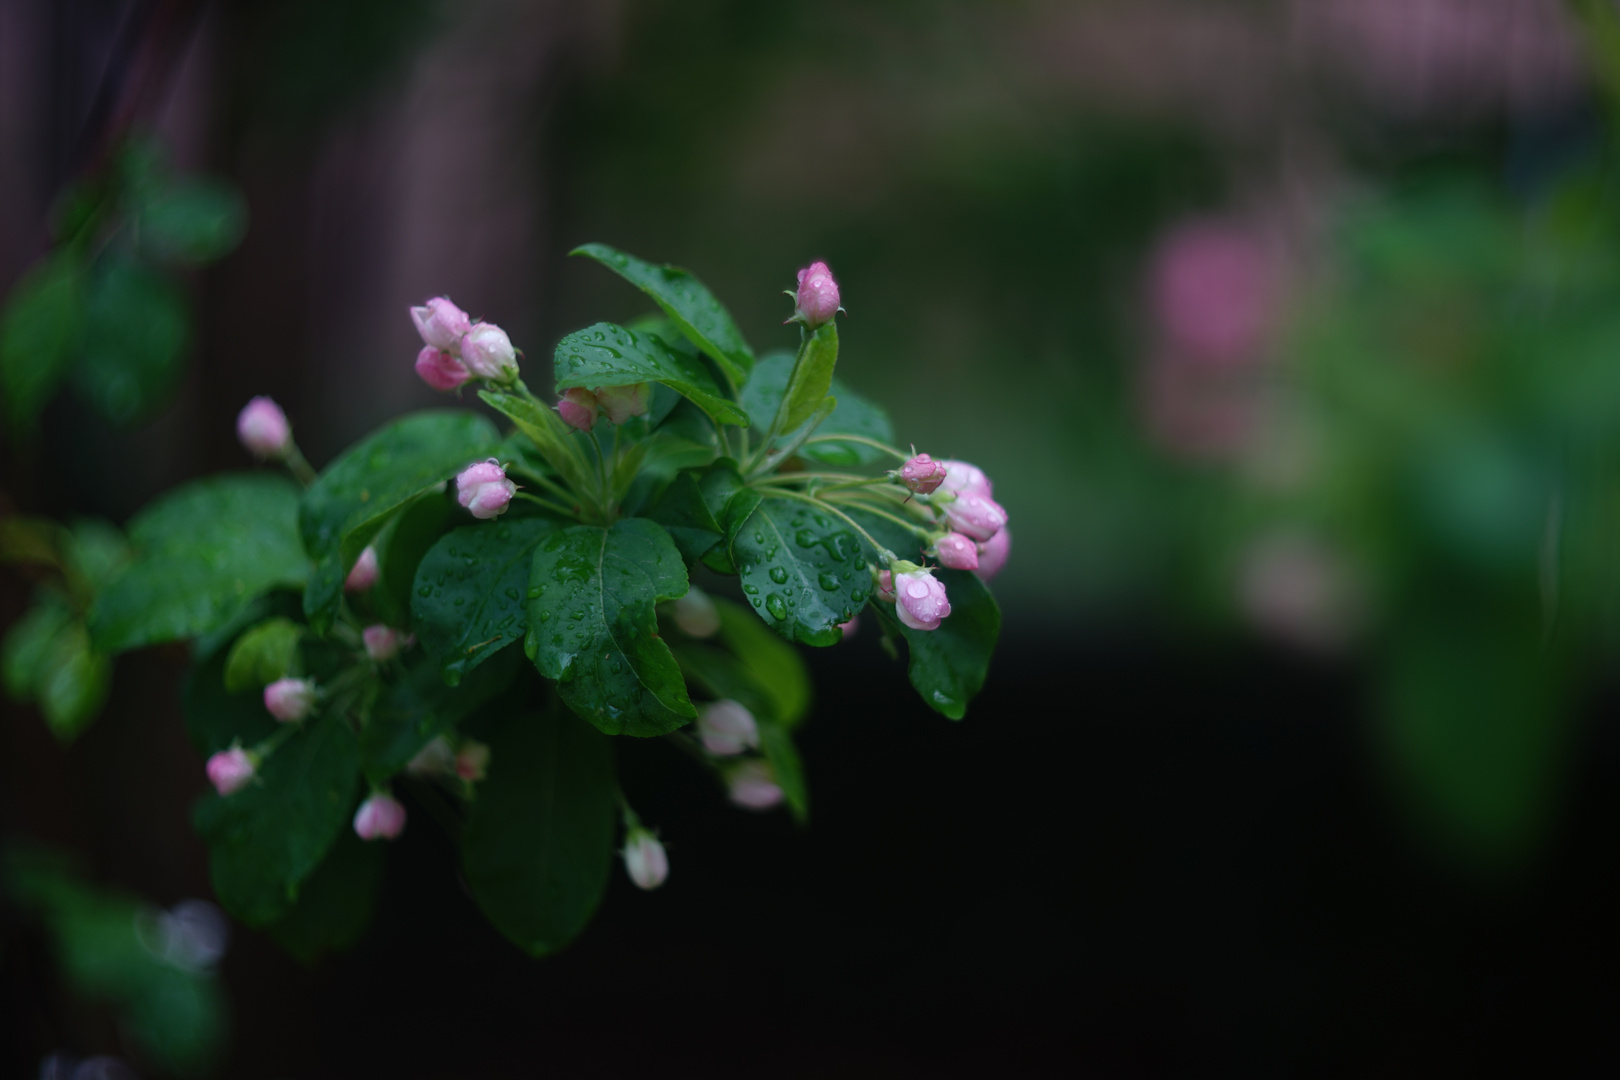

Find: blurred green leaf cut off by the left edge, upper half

[0,249,84,436]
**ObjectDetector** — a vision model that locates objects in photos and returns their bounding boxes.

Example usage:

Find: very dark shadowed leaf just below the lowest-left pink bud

[269,809,387,965]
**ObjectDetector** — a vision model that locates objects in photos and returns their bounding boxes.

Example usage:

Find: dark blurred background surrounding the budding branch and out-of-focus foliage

[0,0,1620,1078]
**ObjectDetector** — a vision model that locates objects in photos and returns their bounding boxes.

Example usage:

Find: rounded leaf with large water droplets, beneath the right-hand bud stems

[731,497,872,644]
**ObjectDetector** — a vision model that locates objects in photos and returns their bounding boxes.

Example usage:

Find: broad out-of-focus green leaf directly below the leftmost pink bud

[91,473,309,653]
